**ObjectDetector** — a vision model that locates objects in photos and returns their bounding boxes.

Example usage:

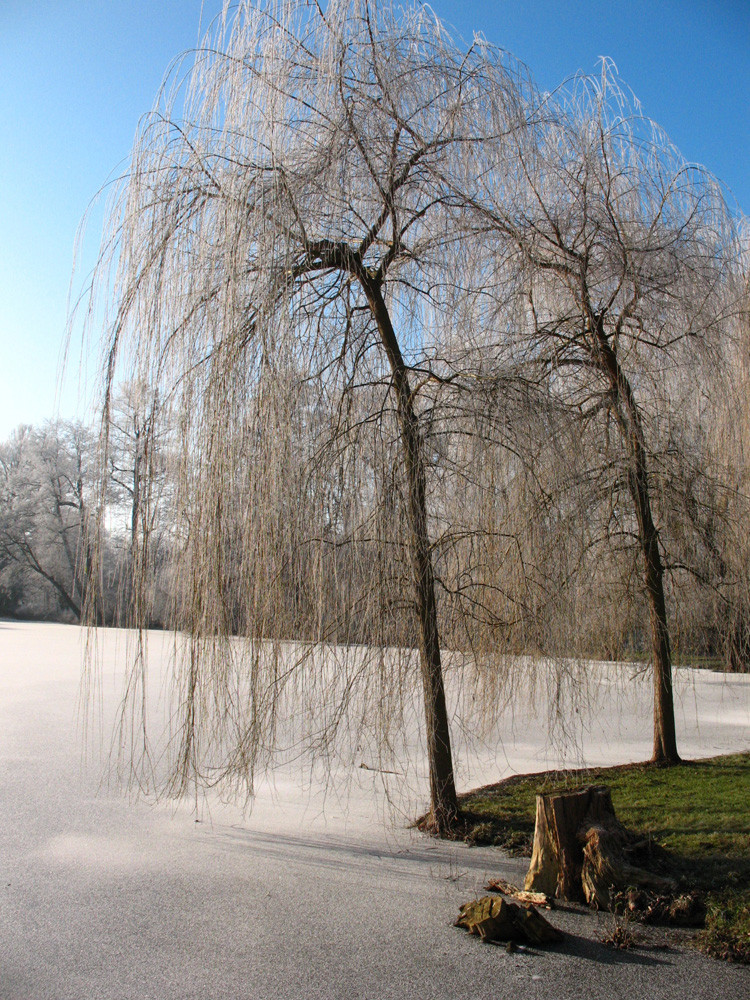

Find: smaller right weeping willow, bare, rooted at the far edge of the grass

[452,64,741,762]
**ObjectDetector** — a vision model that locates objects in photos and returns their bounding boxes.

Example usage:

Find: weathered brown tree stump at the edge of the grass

[524,786,675,909]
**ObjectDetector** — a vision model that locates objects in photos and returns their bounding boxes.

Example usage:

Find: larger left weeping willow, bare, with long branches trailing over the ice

[83,0,548,832]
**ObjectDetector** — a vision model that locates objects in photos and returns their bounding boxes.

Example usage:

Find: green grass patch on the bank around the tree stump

[460,753,750,962]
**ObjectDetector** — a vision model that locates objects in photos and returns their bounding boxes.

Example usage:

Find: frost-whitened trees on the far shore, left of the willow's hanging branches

[0,384,172,628]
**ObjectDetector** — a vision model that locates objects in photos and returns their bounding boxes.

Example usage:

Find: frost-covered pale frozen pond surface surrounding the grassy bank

[0,622,750,1000]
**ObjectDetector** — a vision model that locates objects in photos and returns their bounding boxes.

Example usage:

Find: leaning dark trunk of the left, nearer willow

[359,275,459,835]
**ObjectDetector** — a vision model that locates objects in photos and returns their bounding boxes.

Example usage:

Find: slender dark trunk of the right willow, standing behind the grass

[596,322,680,764]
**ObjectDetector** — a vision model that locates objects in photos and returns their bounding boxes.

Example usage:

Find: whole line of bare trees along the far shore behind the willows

[5,364,750,671]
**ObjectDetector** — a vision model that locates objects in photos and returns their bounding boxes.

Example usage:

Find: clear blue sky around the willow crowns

[0,0,750,439]
